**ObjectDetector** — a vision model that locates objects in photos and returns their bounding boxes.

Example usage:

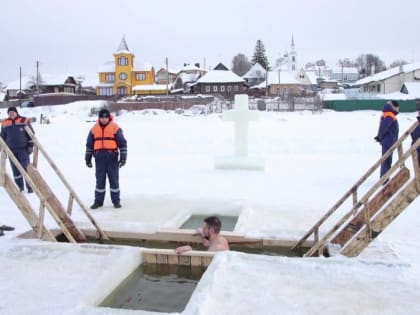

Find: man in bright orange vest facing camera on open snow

[85,108,127,209]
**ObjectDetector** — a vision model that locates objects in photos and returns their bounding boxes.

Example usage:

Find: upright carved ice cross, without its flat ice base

[223,94,258,157]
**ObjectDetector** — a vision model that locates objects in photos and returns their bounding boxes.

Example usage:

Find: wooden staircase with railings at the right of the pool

[292,121,420,257]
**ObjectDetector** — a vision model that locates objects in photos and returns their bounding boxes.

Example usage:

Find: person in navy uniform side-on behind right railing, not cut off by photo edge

[375,101,400,177]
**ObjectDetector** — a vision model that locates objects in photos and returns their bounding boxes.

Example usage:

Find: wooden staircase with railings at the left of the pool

[0,127,108,243]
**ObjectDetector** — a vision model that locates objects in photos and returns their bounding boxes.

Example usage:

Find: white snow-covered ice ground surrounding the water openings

[0,101,420,314]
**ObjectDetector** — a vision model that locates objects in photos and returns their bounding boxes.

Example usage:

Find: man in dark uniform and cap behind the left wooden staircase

[1,107,34,193]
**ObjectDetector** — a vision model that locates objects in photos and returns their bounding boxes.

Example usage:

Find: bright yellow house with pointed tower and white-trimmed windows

[96,37,155,96]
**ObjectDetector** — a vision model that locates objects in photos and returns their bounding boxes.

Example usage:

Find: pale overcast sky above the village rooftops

[0,0,420,83]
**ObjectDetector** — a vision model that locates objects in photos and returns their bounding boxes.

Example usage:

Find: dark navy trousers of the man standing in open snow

[94,150,120,204]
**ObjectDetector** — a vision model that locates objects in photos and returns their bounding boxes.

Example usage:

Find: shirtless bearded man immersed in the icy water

[175,216,229,254]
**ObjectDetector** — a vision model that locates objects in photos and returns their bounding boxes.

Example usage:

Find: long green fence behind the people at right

[324,99,416,113]
